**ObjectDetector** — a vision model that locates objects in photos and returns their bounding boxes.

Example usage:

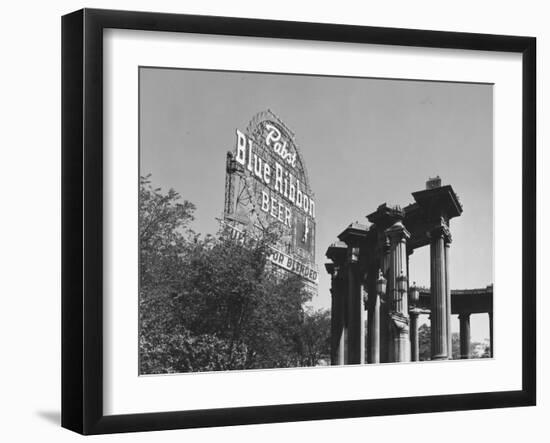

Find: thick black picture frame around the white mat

[62,9,536,434]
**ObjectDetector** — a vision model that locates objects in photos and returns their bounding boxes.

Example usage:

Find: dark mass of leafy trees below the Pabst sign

[139,177,330,373]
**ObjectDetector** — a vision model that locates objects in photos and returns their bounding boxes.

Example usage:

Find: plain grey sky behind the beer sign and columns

[139,68,493,341]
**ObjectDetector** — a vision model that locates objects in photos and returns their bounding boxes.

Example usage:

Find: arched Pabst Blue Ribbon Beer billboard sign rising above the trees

[224,111,317,284]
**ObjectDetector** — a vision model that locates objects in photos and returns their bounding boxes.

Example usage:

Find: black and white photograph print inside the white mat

[136,66,499,376]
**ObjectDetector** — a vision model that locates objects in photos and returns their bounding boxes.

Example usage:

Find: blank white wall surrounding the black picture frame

[0,0,550,443]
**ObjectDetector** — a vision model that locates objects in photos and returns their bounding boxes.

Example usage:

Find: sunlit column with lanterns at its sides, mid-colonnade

[386,221,411,362]
